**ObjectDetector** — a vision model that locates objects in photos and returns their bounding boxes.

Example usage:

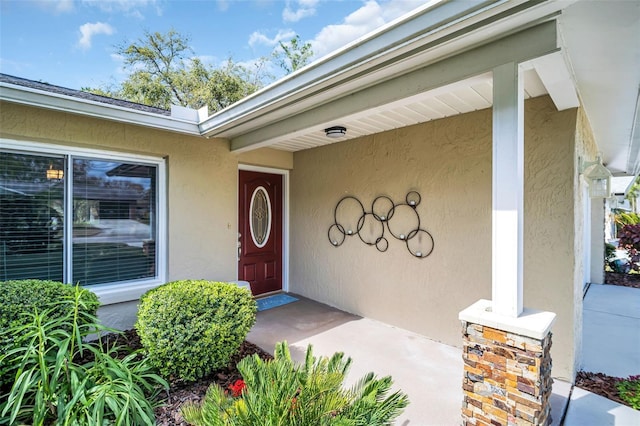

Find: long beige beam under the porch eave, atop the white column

[231,22,558,152]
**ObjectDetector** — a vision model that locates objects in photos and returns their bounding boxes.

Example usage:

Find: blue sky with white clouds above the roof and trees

[0,0,425,89]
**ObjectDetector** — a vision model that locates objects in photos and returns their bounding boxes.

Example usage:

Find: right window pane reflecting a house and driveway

[73,158,156,284]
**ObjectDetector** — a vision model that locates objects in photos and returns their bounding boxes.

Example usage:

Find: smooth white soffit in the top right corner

[558,0,640,175]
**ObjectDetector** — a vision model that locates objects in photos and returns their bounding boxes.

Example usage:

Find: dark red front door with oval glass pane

[238,170,282,295]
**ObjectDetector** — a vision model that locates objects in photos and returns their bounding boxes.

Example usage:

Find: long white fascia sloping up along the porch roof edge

[200,0,524,136]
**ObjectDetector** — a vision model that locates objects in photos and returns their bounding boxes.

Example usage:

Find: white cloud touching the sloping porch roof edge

[311,0,424,58]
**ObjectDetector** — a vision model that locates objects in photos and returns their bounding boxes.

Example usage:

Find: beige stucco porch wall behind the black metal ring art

[290,97,576,377]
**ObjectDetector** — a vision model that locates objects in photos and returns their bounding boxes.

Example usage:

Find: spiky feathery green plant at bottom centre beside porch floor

[182,342,409,426]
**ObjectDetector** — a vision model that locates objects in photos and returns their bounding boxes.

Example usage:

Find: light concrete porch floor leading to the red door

[247,295,571,426]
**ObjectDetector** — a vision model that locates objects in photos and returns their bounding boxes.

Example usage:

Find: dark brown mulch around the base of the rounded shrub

[103,330,273,426]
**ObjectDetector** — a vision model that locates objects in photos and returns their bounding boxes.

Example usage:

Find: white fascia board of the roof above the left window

[0,83,200,136]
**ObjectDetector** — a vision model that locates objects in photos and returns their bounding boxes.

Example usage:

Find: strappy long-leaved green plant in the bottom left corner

[0,287,168,425]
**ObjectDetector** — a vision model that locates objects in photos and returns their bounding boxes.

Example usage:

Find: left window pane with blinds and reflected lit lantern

[0,152,64,281]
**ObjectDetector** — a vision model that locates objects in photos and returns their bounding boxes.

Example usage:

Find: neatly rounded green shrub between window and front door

[135,280,256,381]
